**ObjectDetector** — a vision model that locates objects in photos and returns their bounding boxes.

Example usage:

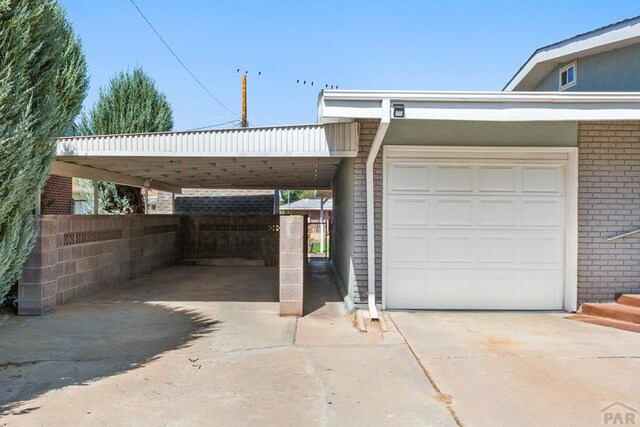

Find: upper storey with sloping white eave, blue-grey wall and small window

[504,17,640,92]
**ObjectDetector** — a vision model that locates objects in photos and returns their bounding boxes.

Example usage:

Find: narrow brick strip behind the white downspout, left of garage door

[353,120,382,304]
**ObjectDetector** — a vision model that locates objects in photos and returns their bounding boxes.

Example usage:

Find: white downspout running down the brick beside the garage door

[366,99,391,320]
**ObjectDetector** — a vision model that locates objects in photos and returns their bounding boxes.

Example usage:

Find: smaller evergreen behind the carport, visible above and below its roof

[78,68,173,214]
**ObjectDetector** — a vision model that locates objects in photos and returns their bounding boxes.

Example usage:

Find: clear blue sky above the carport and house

[60,0,640,130]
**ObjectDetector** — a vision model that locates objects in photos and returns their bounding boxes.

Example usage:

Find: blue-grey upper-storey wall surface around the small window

[534,44,640,92]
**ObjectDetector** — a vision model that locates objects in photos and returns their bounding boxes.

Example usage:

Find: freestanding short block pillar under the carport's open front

[280,215,306,316]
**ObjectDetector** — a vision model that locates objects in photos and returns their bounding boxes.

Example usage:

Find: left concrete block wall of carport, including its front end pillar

[18,215,181,315]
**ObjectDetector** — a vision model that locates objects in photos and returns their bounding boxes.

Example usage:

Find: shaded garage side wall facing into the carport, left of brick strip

[331,158,355,301]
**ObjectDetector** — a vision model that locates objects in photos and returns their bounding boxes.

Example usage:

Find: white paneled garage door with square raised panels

[384,151,566,309]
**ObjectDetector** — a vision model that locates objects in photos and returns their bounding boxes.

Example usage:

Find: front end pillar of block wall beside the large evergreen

[18,219,58,316]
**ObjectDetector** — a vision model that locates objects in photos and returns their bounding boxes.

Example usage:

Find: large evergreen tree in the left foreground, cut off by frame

[0,0,88,302]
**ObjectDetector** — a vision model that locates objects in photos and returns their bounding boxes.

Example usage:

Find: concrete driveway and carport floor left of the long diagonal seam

[0,263,453,425]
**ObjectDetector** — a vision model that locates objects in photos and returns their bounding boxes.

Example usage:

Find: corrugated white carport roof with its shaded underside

[52,123,358,193]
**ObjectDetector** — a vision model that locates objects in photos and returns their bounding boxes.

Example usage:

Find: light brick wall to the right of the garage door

[578,121,640,303]
